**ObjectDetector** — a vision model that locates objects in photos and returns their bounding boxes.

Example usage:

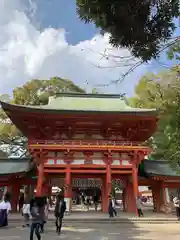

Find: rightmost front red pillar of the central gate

[132,163,139,215]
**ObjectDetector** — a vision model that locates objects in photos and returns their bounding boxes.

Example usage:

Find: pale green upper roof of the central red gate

[1,93,156,115]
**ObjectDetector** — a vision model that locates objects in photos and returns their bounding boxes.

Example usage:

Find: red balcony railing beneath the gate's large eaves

[29,140,141,146]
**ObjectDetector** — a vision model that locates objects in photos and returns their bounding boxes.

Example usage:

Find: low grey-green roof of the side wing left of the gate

[0,158,32,175]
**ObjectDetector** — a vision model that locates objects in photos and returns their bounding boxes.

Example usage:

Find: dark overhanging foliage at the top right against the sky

[76,0,180,61]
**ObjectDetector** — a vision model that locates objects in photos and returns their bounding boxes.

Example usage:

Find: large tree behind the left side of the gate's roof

[0,77,85,155]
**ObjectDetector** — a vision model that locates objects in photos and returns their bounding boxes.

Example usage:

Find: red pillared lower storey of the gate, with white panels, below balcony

[29,140,149,212]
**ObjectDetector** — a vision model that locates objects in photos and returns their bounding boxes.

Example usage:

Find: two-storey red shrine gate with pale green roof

[0,93,159,212]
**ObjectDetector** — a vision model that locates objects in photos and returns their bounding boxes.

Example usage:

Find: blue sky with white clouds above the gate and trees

[0,0,180,96]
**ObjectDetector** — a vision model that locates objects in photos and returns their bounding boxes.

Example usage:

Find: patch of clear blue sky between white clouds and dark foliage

[32,0,99,44]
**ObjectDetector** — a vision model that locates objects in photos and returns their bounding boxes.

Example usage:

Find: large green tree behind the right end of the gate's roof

[129,66,180,165]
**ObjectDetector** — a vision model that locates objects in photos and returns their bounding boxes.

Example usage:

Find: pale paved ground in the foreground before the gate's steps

[0,224,180,240]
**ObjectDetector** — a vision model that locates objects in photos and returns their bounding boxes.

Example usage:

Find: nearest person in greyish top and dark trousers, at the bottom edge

[30,199,42,240]
